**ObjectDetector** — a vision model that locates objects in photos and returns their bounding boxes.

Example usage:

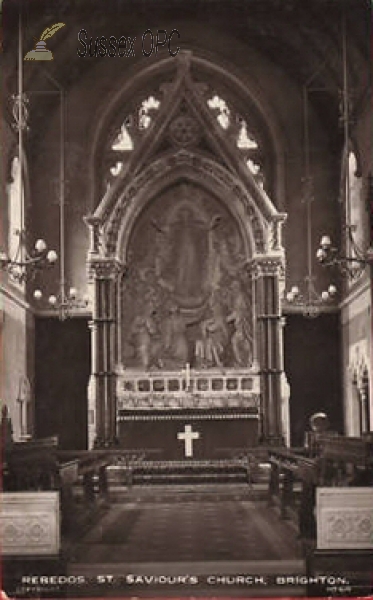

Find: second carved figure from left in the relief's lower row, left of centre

[163,305,189,365]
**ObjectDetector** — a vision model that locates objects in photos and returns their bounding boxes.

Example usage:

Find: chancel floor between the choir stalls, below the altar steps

[72,486,302,563]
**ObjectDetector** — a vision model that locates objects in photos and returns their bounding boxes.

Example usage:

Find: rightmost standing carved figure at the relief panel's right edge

[227,281,253,367]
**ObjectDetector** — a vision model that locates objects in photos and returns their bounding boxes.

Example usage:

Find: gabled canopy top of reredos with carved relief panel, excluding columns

[87,53,285,369]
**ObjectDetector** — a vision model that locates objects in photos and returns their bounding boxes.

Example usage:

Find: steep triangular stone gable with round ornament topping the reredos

[95,52,284,241]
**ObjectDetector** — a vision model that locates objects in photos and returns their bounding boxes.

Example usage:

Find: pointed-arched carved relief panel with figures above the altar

[120,183,253,369]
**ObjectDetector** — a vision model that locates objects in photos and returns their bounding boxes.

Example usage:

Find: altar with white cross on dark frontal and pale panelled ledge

[116,368,260,461]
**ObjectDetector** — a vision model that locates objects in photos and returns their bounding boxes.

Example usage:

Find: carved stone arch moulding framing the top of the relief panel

[101,150,286,266]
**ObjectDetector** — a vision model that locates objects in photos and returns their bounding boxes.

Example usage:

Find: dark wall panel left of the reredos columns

[35,317,90,449]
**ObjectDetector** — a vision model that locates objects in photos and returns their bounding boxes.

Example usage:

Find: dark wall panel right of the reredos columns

[284,313,343,446]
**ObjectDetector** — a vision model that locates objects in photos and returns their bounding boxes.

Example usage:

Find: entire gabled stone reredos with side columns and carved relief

[86,52,285,445]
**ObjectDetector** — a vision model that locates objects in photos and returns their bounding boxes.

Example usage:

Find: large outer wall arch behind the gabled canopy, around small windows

[90,51,287,210]
